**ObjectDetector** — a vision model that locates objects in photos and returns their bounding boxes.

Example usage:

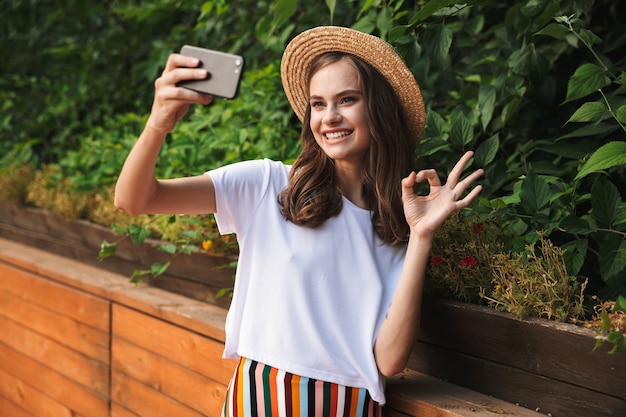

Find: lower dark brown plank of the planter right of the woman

[409,344,626,417]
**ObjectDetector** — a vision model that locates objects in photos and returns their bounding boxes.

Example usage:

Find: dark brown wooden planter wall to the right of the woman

[409,300,626,417]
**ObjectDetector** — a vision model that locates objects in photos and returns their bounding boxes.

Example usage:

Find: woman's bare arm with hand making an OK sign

[374,152,483,376]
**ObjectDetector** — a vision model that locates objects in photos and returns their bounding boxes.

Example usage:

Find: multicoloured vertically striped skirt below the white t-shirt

[222,358,384,417]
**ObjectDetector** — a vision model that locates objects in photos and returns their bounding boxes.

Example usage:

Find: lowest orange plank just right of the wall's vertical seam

[111,370,203,417]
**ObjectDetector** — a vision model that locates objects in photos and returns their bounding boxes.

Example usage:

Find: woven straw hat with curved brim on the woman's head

[280,26,426,143]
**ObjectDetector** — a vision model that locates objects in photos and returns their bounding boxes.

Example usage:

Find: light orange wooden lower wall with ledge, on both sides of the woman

[0,238,540,417]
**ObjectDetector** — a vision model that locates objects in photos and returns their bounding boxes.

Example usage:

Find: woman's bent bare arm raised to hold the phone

[115,54,215,215]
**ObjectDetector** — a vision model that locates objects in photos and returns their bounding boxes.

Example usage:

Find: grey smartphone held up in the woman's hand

[178,45,244,100]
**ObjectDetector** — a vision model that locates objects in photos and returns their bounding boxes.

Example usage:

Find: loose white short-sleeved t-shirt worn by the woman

[207,159,406,404]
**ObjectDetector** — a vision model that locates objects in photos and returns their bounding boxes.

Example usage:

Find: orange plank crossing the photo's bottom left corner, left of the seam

[0,369,72,417]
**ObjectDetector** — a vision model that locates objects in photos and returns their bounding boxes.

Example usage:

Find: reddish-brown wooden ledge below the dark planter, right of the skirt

[387,369,540,417]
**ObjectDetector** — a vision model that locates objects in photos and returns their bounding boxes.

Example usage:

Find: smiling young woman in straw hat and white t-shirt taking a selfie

[116,27,482,416]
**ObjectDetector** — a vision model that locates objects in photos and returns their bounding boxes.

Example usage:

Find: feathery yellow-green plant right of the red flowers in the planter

[481,234,587,322]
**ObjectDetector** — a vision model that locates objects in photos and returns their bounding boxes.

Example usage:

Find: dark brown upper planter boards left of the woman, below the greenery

[0,201,236,307]
